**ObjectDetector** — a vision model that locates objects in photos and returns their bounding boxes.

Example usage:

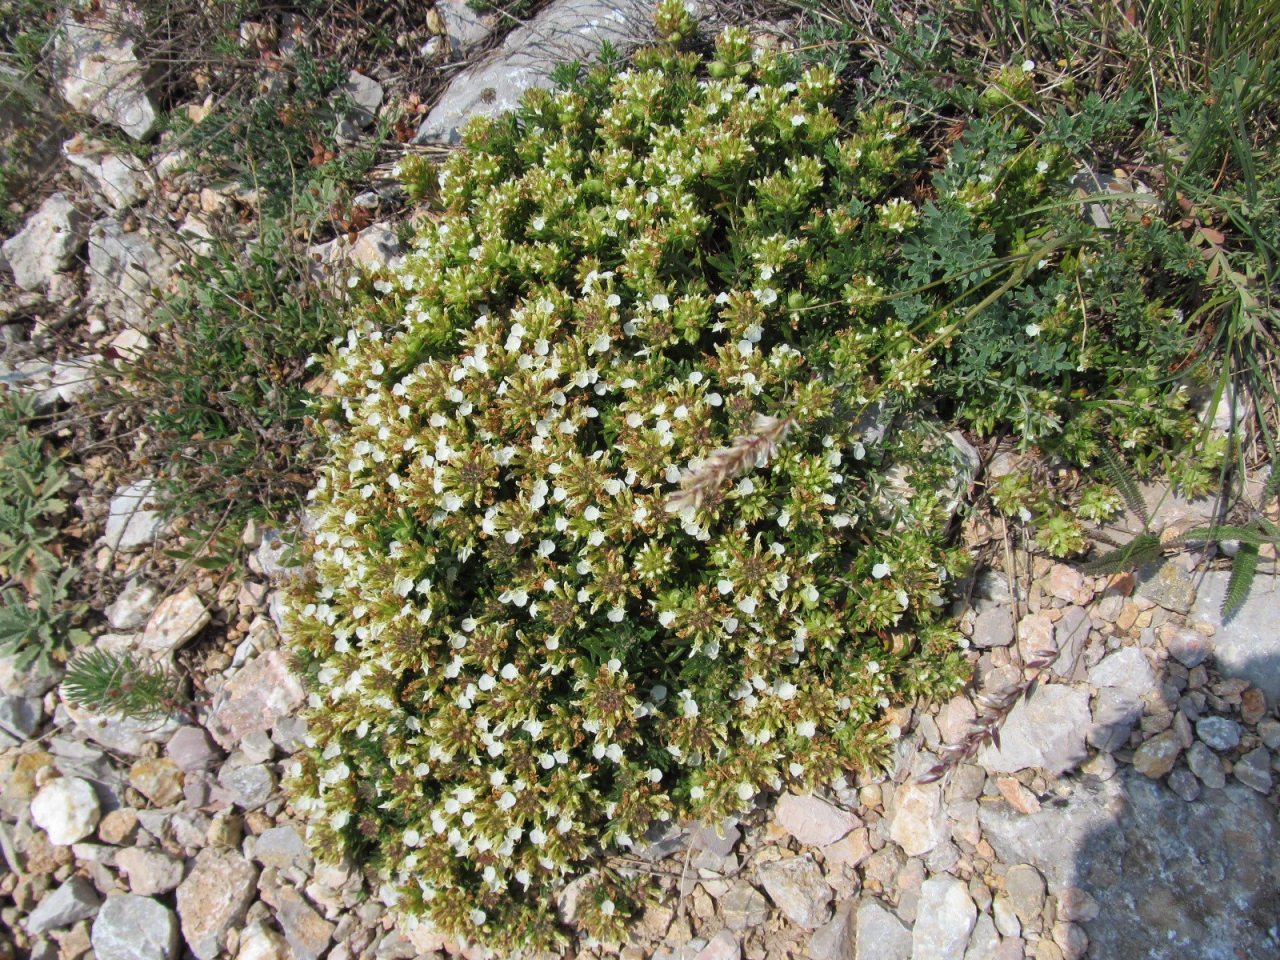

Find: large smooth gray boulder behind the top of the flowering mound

[417,0,653,143]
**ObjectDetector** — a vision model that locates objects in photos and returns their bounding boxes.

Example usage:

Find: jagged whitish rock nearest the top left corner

[54,4,157,140]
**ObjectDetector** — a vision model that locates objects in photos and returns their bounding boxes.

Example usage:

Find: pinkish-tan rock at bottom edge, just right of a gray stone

[178,847,257,960]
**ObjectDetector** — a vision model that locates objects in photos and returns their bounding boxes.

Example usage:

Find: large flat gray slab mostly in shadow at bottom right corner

[979,771,1280,960]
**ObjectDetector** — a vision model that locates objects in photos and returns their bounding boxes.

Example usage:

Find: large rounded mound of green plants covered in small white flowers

[282,5,1208,948]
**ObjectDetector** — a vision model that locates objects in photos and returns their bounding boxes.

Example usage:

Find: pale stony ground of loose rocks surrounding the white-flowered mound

[0,0,1280,960]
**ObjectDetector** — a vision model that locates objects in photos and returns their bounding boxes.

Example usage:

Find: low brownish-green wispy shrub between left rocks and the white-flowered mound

[102,220,340,529]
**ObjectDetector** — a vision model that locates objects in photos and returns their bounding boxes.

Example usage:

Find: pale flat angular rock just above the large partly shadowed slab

[978,684,1091,773]
